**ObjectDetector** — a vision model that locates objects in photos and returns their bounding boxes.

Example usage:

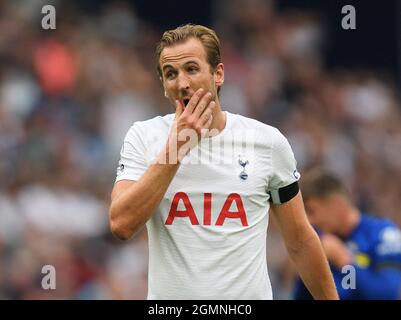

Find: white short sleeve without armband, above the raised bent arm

[116,123,148,182]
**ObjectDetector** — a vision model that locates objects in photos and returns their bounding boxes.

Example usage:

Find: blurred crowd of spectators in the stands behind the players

[0,0,401,299]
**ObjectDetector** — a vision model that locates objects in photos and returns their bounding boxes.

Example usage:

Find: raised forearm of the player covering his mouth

[110,148,179,240]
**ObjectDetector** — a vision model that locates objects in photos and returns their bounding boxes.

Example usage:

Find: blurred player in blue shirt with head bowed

[294,169,401,299]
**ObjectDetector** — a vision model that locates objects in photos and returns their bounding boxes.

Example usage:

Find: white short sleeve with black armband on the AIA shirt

[267,130,300,204]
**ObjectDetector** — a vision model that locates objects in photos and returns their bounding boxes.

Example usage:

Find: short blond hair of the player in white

[156,24,221,77]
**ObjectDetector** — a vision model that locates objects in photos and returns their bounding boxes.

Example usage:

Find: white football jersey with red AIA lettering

[116,112,299,300]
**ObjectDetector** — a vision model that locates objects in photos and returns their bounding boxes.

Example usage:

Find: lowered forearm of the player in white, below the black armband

[289,230,338,300]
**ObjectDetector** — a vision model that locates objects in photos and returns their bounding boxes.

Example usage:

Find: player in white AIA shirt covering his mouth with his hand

[110,24,338,300]
